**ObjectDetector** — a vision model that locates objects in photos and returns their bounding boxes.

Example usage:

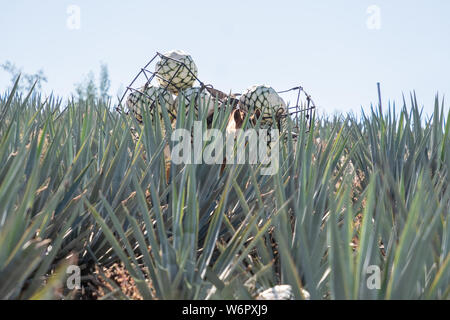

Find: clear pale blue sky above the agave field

[0,0,450,113]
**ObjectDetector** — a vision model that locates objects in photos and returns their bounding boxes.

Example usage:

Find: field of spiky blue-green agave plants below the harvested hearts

[0,77,450,300]
